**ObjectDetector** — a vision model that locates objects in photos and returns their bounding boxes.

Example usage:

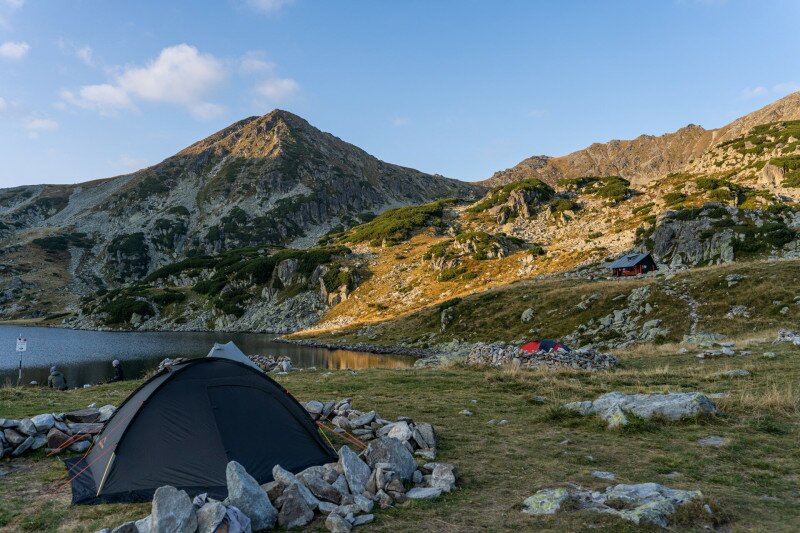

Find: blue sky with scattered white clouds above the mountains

[0,0,800,187]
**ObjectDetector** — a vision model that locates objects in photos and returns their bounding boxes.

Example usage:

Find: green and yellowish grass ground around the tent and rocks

[0,334,800,532]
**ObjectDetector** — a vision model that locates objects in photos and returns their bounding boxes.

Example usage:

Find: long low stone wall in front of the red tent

[467,343,617,370]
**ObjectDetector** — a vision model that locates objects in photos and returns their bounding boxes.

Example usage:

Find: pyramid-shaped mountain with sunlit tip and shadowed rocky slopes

[0,110,482,304]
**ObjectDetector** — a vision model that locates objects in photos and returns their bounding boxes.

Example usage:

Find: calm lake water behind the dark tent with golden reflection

[0,325,414,387]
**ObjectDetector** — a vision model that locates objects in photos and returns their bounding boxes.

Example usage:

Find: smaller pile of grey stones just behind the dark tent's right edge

[305,398,436,461]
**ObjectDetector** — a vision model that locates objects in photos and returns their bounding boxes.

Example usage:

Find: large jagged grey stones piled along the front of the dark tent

[102,421,458,533]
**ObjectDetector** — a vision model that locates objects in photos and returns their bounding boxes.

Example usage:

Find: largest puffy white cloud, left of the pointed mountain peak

[61,44,225,118]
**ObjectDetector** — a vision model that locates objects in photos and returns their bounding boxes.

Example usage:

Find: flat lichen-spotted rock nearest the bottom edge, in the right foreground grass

[522,483,713,528]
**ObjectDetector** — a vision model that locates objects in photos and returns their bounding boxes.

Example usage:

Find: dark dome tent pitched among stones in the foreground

[66,357,337,504]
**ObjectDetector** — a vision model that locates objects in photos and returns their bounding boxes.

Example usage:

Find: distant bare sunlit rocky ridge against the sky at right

[482,93,800,187]
